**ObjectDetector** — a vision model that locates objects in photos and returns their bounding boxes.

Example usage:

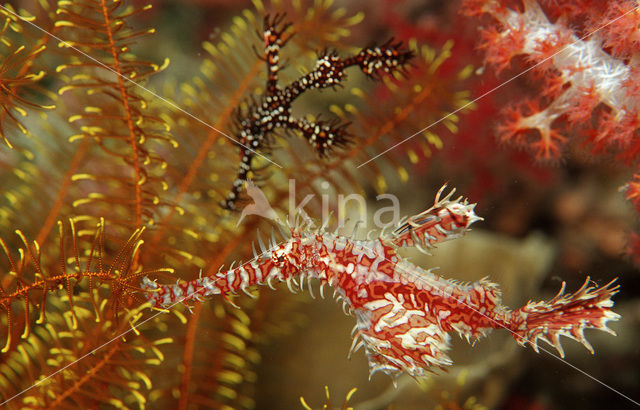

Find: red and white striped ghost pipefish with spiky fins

[142,187,620,377]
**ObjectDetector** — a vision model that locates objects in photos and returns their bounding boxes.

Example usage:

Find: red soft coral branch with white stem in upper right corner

[466,0,639,159]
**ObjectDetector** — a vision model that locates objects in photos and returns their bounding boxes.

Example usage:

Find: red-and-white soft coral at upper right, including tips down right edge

[463,0,640,266]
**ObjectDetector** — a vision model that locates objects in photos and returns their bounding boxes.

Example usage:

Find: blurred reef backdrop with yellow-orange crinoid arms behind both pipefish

[0,0,640,409]
